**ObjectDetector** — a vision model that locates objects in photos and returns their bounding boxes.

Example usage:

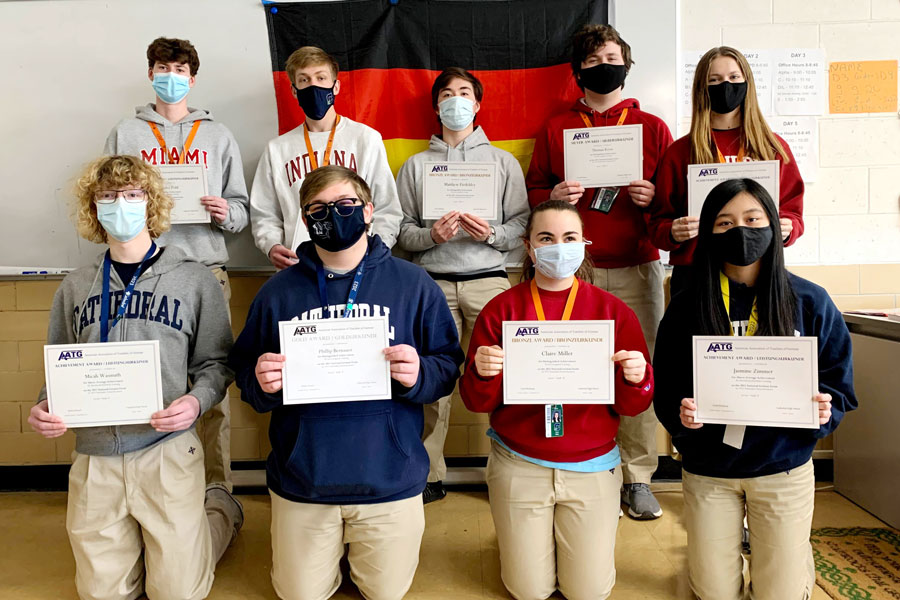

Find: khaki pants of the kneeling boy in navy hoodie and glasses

[270,491,425,600]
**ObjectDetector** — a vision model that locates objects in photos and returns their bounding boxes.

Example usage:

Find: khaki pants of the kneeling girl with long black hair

[683,461,816,600]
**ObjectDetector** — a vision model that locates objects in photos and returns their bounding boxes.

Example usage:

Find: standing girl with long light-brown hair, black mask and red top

[650,46,803,293]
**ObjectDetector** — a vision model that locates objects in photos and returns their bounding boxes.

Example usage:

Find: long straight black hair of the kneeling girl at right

[691,179,797,335]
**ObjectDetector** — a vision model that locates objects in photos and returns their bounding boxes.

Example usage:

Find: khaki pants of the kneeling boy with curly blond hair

[66,430,234,600]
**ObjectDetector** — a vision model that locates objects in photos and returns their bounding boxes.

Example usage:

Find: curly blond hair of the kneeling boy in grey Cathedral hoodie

[74,156,174,244]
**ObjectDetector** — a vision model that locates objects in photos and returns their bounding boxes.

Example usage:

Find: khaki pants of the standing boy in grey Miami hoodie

[195,268,233,492]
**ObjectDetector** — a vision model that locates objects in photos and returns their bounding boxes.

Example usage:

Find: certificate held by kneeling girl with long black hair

[694,336,819,429]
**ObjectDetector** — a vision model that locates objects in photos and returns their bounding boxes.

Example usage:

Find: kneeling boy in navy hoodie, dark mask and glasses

[230,165,463,600]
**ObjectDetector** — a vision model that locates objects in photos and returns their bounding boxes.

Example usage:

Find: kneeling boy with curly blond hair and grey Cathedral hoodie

[28,156,243,600]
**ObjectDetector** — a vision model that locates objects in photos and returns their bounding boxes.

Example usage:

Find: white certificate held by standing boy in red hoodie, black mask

[563,125,644,188]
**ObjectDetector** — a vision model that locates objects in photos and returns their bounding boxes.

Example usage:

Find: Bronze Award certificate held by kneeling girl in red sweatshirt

[503,321,615,404]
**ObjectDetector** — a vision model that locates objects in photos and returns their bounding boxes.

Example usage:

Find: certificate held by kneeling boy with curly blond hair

[44,340,163,427]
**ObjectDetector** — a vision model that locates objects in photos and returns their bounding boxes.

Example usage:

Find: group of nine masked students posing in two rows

[29,25,856,600]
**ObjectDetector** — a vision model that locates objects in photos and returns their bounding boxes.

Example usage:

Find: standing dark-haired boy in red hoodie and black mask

[525,25,672,519]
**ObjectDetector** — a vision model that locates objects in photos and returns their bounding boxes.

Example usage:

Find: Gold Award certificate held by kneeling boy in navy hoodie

[278,316,391,404]
